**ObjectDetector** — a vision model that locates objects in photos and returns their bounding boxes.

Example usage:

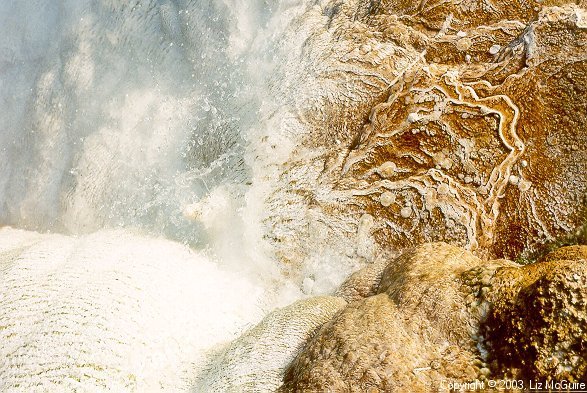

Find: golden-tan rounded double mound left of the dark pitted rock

[282,243,500,392]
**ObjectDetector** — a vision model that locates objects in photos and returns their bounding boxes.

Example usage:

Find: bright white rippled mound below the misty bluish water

[0,228,266,393]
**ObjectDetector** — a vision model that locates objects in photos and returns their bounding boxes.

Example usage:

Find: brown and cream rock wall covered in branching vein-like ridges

[258,0,587,278]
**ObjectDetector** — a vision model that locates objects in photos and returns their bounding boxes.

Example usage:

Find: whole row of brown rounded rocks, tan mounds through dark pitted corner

[280,243,587,392]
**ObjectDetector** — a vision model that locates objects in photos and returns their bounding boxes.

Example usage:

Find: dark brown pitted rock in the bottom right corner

[481,249,587,382]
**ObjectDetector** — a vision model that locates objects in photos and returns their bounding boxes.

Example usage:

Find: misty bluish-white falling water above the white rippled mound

[0,0,310,278]
